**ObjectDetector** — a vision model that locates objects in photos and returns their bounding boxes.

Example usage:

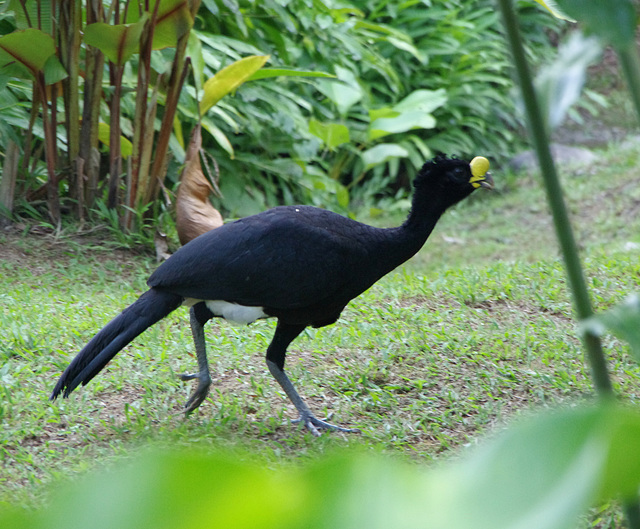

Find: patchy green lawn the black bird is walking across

[0,141,640,527]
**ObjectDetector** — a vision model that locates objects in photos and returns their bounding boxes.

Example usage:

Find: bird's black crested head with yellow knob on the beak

[414,155,493,208]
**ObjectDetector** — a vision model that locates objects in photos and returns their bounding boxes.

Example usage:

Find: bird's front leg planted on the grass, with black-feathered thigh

[267,322,359,436]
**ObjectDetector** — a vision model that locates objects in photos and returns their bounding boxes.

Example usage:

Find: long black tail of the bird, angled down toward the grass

[51,288,183,400]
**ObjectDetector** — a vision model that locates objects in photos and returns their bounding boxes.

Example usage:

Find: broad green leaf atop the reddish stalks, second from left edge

[84,14,148,66]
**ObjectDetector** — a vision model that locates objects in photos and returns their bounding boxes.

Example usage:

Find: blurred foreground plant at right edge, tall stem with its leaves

[498,0,640,529]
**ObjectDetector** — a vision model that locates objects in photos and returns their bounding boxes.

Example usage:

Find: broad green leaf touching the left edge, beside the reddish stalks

[0,29,56,77]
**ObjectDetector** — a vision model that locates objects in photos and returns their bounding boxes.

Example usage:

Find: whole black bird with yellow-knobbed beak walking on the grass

[51,156,493,435]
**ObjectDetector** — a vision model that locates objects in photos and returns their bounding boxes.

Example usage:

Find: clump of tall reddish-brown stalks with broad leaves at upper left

[0,0,199,228]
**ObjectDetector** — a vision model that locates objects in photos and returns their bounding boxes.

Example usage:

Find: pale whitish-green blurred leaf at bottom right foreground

[427,410,607,529]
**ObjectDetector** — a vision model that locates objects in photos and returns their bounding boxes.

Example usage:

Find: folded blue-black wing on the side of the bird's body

[148,208,366,309]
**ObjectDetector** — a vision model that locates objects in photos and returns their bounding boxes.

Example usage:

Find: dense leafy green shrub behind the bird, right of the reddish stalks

[182,0,557,215]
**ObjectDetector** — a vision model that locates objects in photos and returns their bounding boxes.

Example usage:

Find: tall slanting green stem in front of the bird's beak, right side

[498,0,613,397]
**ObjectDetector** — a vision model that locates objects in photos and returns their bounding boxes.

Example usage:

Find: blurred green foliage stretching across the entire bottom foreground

[0,403,640,529]
